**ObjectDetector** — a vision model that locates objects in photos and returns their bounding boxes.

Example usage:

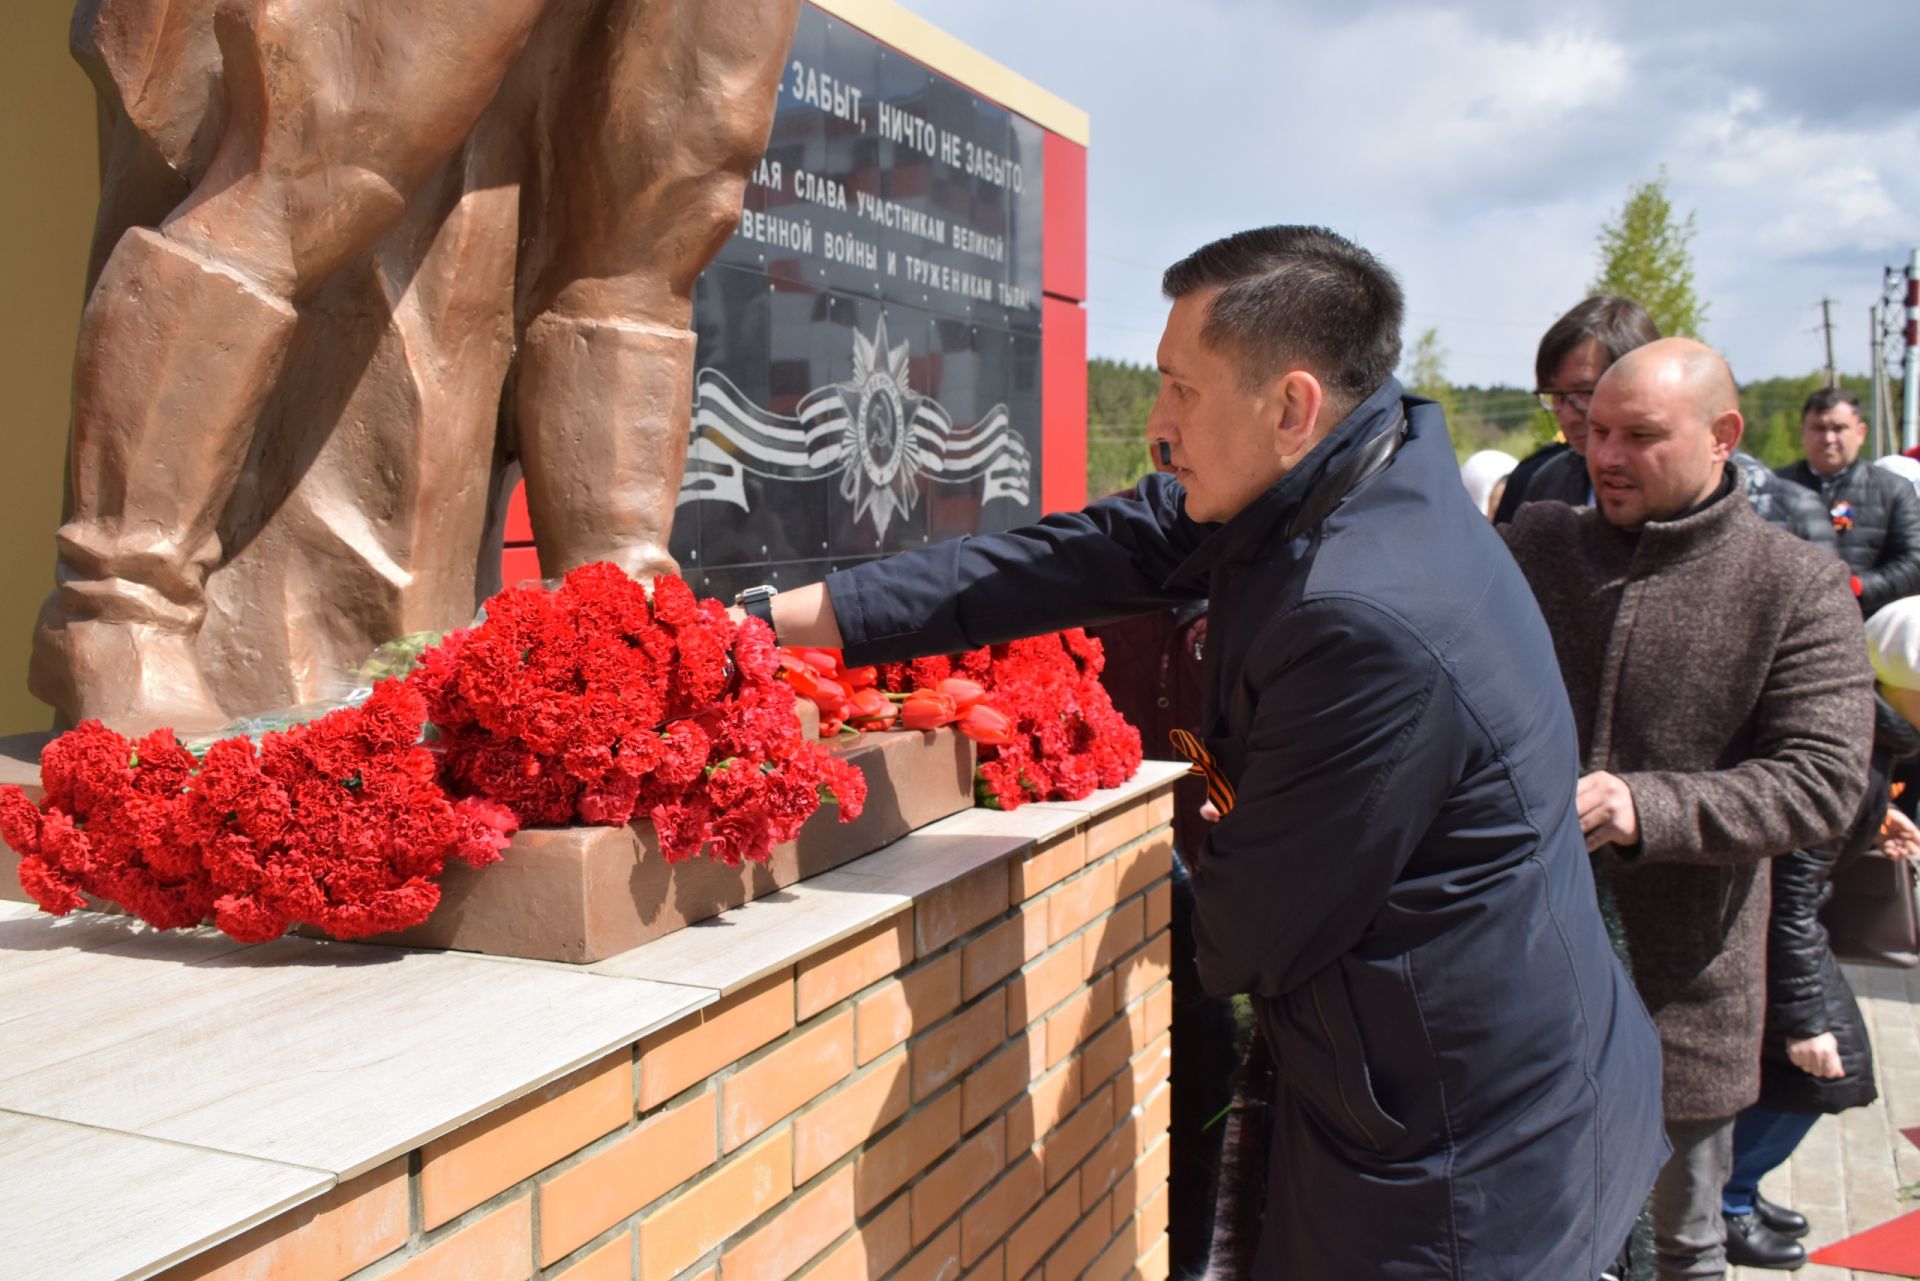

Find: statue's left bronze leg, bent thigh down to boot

[29,0,547,730]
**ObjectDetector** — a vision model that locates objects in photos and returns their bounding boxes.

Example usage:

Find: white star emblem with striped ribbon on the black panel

[680,317,1033,538]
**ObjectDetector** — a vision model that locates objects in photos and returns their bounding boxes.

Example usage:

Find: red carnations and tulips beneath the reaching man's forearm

[781,628,1140,809]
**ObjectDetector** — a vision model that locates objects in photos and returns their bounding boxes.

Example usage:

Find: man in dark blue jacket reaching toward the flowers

[768,227,1667,1281]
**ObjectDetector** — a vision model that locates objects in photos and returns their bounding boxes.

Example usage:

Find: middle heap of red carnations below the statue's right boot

[420,565,866,864]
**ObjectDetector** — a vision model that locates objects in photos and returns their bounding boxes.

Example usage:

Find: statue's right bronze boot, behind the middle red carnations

[515,315,693,578]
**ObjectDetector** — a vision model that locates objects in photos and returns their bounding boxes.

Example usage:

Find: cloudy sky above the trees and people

[904,0,1920,384]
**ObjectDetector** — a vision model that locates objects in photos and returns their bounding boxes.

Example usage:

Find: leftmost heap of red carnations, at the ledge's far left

[0,680,516,943]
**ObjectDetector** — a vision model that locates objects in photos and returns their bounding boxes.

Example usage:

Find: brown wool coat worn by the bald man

[1507,486,1874,1122]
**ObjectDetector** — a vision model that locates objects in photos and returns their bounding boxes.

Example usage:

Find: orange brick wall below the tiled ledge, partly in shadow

[163,789,1173,1281]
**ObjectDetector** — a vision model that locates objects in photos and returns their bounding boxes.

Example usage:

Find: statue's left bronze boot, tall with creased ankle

[27,229,296,734]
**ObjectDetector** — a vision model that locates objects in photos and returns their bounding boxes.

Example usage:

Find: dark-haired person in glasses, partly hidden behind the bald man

[1494,294,1661,524]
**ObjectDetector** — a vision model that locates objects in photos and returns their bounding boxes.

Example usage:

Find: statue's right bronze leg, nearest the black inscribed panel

[515,0,799,574]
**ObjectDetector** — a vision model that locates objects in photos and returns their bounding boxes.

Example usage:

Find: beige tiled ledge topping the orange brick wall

[0,762,1185,1281]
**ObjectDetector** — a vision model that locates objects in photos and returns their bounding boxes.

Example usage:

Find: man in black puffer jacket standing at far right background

[1776,388,1920,618]
